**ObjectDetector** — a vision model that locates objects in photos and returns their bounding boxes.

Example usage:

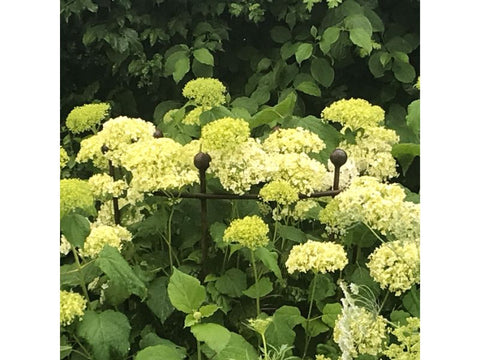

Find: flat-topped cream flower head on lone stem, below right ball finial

[285,240,348,274]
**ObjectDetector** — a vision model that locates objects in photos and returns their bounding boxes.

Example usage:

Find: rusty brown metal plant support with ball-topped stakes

[107,143,347,272]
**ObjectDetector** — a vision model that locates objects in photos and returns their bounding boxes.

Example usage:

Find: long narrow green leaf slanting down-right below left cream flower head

[95,245,147,299]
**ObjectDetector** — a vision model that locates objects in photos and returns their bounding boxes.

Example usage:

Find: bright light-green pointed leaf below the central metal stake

[167,268,207,314]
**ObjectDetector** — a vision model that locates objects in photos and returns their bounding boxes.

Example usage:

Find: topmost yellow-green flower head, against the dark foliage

[182,78,227,107]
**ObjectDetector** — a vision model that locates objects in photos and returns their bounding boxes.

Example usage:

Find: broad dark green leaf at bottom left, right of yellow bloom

[77,310,131,360]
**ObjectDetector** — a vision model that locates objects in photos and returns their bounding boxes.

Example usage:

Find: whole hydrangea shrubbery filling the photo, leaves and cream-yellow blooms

[60,0,420,360]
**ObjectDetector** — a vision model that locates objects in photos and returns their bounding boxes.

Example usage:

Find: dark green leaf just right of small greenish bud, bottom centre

[265,305,305,347]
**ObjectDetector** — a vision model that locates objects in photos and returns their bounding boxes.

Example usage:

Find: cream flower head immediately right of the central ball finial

[209,138,278,195]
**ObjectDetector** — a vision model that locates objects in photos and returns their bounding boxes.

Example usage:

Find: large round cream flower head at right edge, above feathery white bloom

[367,240,420,296]
